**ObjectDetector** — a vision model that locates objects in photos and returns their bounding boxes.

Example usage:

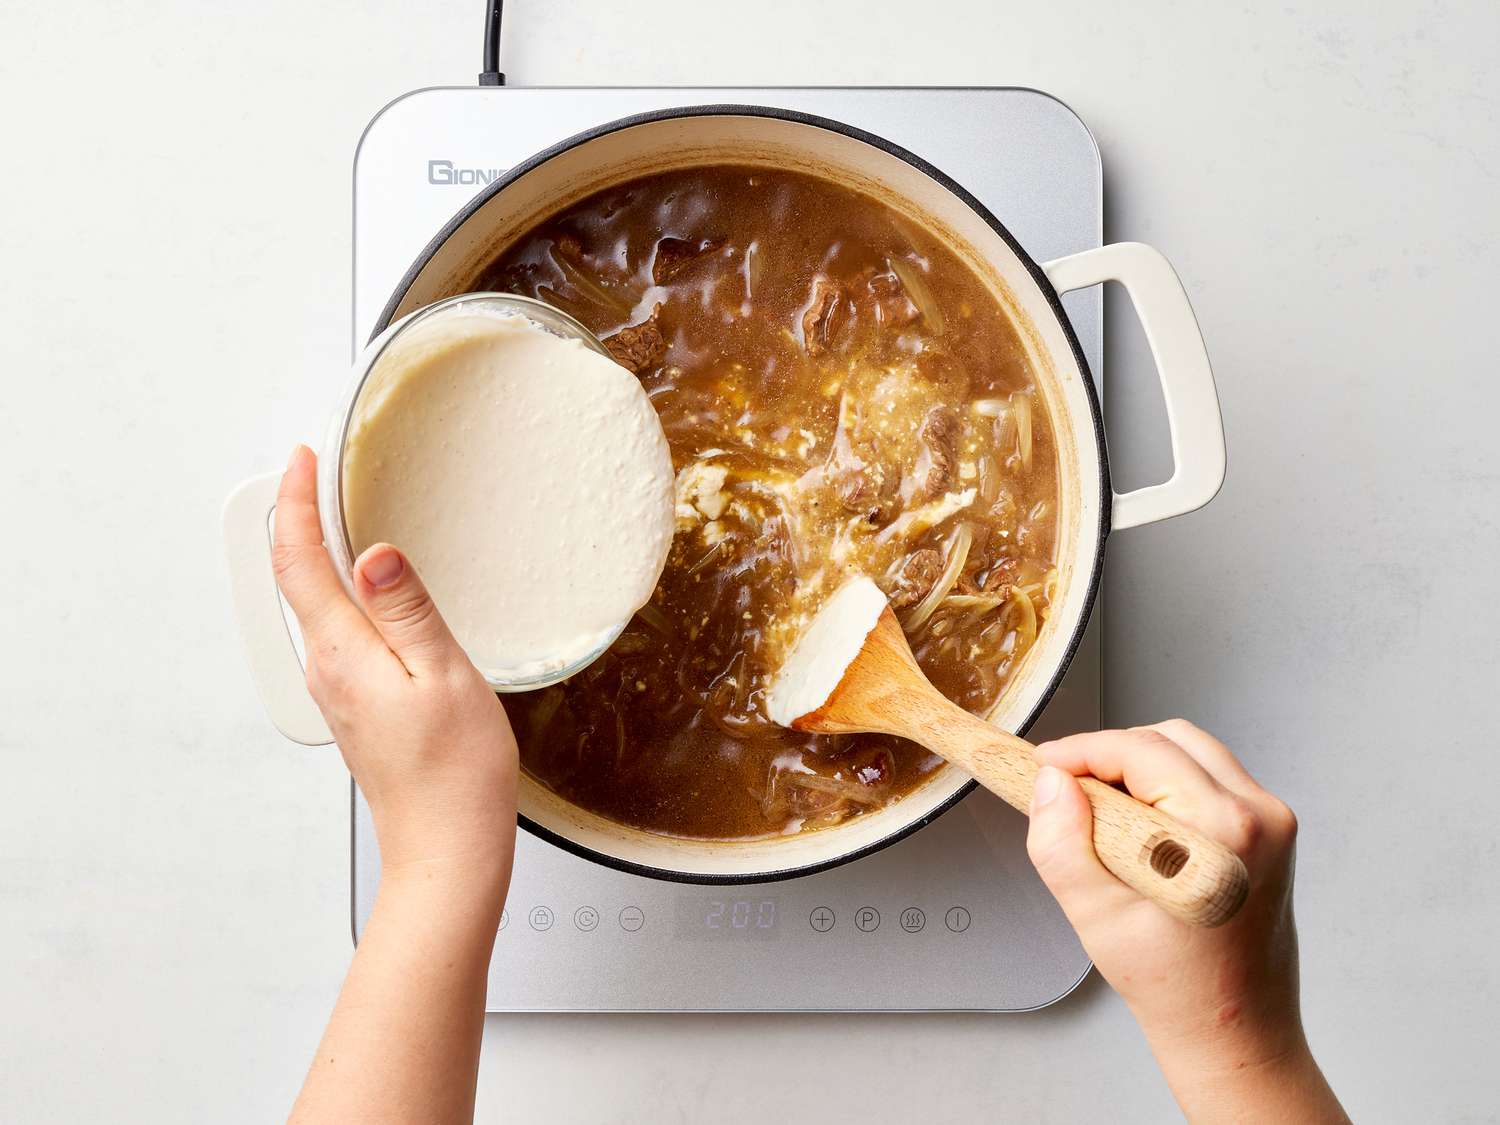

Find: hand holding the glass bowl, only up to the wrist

[275,446,518,882]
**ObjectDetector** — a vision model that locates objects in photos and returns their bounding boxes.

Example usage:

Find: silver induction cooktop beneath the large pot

[351,87,1103,1011]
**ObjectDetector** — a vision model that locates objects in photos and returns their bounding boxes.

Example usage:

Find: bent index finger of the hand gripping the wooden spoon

[1038,728,1226,816]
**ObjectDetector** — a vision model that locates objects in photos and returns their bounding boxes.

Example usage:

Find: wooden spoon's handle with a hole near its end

[909,701,1250,927]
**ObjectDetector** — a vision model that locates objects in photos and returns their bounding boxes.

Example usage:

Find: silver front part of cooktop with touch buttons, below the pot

[438,774,1088,1010]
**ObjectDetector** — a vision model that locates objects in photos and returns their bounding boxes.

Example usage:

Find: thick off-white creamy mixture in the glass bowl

[344,303,674,681]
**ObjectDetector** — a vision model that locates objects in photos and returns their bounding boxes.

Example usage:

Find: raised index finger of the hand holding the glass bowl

[272,446,372,651]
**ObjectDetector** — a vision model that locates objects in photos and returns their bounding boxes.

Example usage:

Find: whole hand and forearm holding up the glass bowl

[273,446,519,1122]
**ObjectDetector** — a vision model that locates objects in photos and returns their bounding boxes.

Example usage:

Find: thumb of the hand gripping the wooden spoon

[1026,765,1137,933]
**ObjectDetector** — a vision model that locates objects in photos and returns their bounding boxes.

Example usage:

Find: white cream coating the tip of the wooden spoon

[767,578,887,726]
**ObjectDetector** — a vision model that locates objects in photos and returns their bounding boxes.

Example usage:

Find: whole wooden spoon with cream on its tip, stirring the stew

[768,579,1250,927]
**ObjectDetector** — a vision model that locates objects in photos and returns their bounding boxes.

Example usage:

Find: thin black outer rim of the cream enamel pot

[371,102,1113,887]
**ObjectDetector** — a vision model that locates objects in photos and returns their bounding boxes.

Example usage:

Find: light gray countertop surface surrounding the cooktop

[0,0,1500,1122]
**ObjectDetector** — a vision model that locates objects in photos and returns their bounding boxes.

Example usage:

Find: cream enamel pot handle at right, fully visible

[1041,242,1224,530]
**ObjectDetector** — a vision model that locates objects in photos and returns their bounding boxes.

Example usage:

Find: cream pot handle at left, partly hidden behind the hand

[224,473,333,746]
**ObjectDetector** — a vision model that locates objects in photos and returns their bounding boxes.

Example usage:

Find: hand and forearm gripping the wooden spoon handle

[1026,719,1344,1121]
